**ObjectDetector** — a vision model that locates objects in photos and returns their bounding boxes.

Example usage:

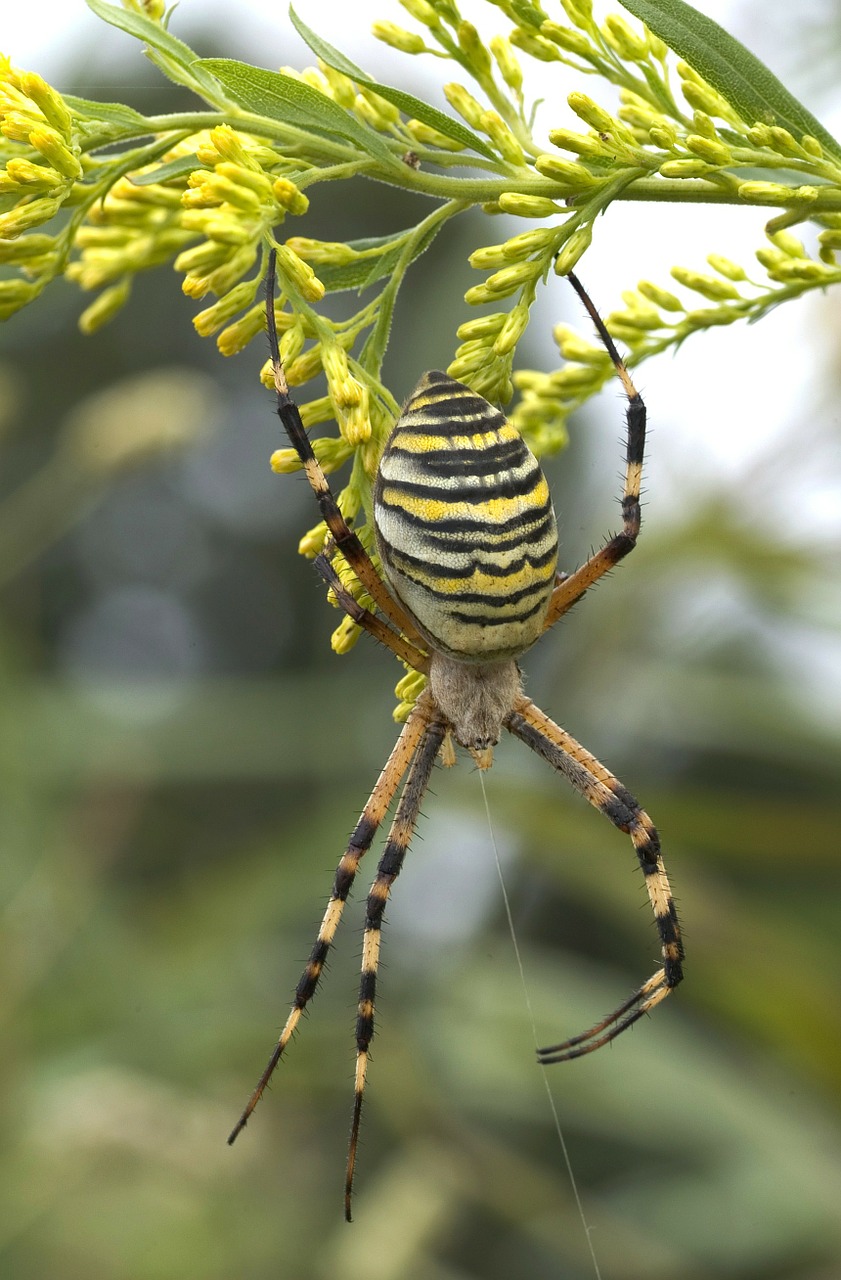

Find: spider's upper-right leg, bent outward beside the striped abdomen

[544,271,645,631]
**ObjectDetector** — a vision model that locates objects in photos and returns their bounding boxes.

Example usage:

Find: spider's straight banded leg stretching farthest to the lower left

[228,694,440,1144]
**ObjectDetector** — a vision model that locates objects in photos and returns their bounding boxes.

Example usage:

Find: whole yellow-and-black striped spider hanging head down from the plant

[228,252,684,1222]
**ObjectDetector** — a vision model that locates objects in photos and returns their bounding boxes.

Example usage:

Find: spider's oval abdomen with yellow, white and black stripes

[374,372,558,662]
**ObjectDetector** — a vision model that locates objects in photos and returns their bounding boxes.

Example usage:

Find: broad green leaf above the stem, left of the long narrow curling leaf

[195,58,399,169]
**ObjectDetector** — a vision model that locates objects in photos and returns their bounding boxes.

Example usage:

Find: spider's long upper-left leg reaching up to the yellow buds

[266,250,422,644]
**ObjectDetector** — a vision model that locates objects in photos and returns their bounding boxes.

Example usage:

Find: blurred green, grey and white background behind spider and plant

[0,0,841,1280]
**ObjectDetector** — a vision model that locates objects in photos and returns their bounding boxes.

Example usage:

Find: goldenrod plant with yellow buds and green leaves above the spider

[0,0,841,701]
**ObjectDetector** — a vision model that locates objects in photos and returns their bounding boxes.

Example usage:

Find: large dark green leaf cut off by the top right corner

[622,0,841,159]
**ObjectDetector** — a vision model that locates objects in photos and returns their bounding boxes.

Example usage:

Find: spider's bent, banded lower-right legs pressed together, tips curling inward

[504,696,684,1065]
